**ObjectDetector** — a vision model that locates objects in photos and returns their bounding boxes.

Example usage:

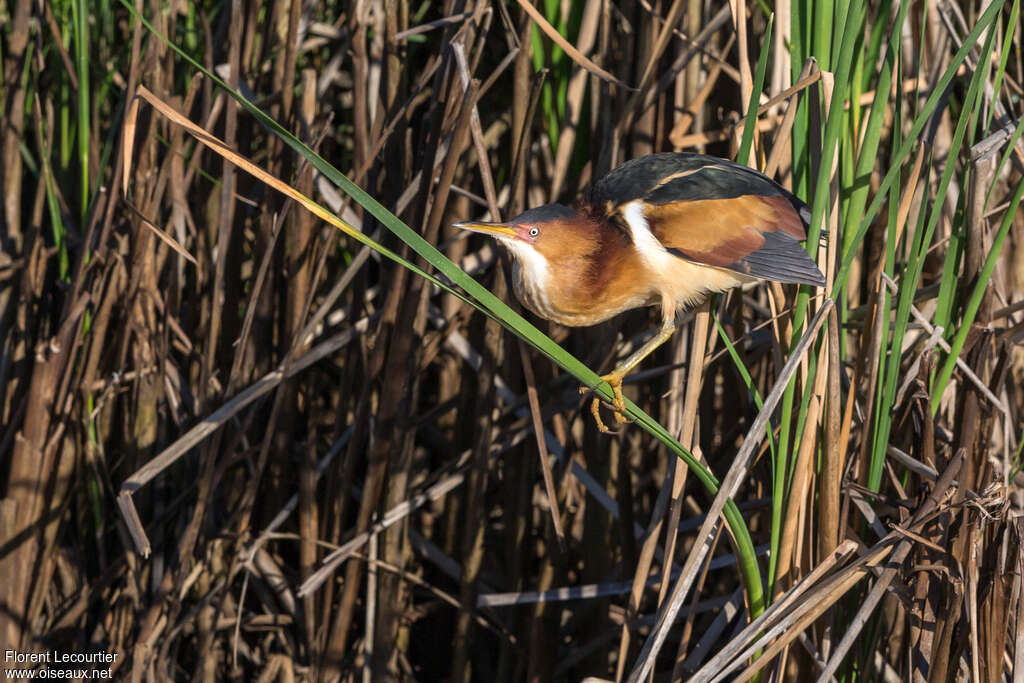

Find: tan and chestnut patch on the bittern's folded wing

[644,195,806,267]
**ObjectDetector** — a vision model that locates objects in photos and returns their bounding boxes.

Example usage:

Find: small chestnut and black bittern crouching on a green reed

[454,153,825,433]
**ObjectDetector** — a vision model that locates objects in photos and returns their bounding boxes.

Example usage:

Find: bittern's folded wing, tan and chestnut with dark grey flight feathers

[644,195,824,286]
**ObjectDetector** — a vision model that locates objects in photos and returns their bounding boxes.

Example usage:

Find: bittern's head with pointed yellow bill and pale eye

[455,204,596,269]
